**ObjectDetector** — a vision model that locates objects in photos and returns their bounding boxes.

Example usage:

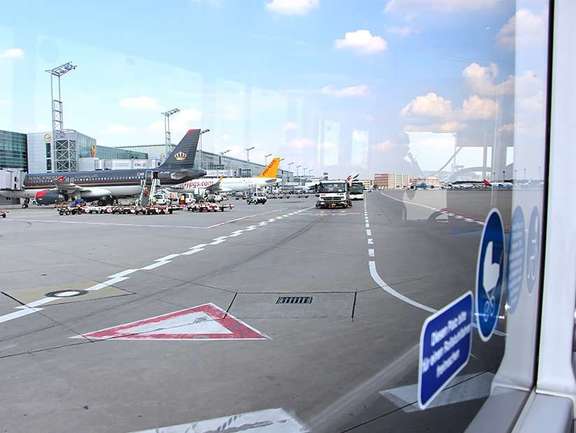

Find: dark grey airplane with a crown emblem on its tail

[0,129,206,204]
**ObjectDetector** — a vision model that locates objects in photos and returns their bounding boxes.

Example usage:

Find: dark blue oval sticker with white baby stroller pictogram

[475,209,504,341]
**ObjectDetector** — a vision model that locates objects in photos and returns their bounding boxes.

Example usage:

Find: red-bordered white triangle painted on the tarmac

[75,303,267,341]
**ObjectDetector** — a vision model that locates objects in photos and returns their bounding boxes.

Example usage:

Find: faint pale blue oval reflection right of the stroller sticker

[506,206,526,313]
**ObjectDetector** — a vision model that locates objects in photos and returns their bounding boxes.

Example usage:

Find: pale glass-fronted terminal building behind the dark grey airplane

[27,129,148,173]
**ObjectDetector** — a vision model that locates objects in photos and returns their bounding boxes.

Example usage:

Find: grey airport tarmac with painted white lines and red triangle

[0,191,511,433]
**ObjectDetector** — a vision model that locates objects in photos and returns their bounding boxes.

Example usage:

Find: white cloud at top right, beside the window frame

[496,9,547,48]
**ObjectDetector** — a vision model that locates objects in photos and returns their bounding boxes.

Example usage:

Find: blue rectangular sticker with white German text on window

[418,292,473,409]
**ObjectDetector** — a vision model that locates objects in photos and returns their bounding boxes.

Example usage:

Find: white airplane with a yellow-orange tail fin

[177,158,280,192]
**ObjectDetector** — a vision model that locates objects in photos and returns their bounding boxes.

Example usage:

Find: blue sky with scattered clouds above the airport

[0,0,546,176]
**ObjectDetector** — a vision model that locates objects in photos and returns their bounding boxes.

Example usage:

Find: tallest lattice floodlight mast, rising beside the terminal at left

[45,62,77,171]
